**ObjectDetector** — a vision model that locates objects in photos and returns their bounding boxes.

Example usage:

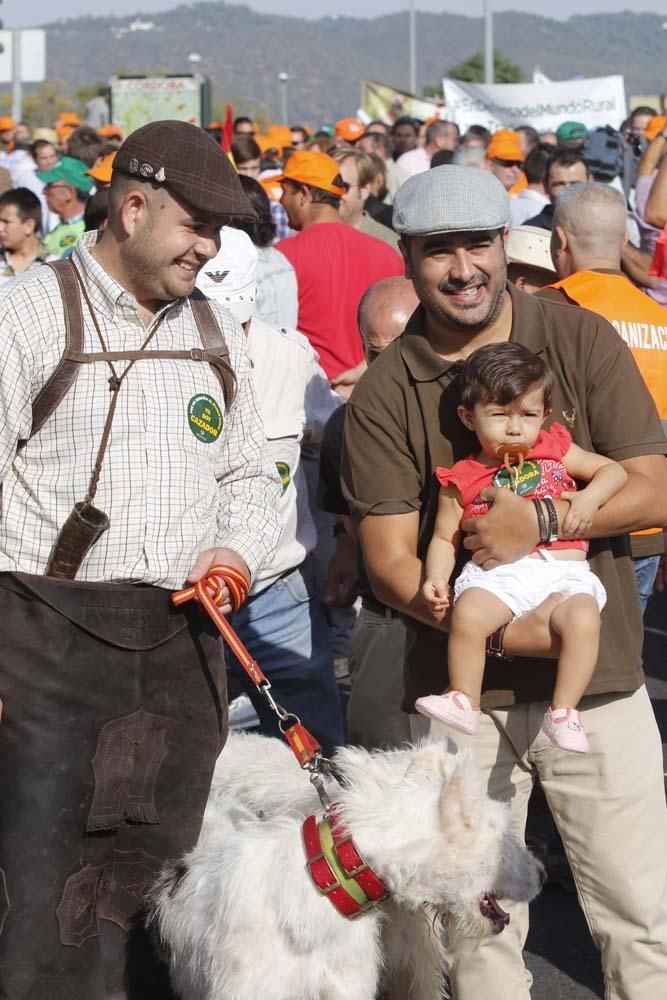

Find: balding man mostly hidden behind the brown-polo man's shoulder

[317,278,419,749]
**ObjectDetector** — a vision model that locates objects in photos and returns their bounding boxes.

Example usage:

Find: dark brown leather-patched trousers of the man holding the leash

[0,573,227,1000]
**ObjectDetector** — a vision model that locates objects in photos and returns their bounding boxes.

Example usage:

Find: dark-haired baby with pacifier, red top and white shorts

[416,343,627,753]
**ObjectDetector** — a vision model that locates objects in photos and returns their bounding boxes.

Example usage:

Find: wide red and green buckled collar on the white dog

[303,816,387,919]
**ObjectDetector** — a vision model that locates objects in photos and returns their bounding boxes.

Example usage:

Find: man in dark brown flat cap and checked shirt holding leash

[0,121,280,1000]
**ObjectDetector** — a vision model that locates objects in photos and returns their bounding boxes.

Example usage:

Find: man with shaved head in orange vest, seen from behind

[538,184,667,611]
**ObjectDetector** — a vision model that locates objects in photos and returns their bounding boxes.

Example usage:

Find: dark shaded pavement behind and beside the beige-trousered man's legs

[526,592,667,1000]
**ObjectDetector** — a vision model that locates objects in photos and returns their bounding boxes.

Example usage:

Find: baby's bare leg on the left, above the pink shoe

[447,587,512,708]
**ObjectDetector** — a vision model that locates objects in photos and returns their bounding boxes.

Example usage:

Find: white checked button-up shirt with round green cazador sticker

[0,233,280,589]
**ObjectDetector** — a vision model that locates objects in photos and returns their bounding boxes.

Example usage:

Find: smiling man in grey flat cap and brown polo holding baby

[342,166,667,1000]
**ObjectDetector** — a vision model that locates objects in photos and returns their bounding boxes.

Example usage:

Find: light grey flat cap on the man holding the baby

[393,164,510,236]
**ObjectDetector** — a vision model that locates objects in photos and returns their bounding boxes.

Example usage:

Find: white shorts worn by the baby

[454,552,607,618]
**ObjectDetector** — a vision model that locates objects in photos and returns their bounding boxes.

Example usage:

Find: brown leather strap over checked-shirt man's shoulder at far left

[19,260,83,450]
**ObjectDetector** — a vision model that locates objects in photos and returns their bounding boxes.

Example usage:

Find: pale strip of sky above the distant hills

[7,0,667,28]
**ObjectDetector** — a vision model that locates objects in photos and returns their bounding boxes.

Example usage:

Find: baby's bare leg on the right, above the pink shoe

[549,594,600,708]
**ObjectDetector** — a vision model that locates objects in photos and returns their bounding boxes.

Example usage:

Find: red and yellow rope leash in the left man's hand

[172,566,322,767]
